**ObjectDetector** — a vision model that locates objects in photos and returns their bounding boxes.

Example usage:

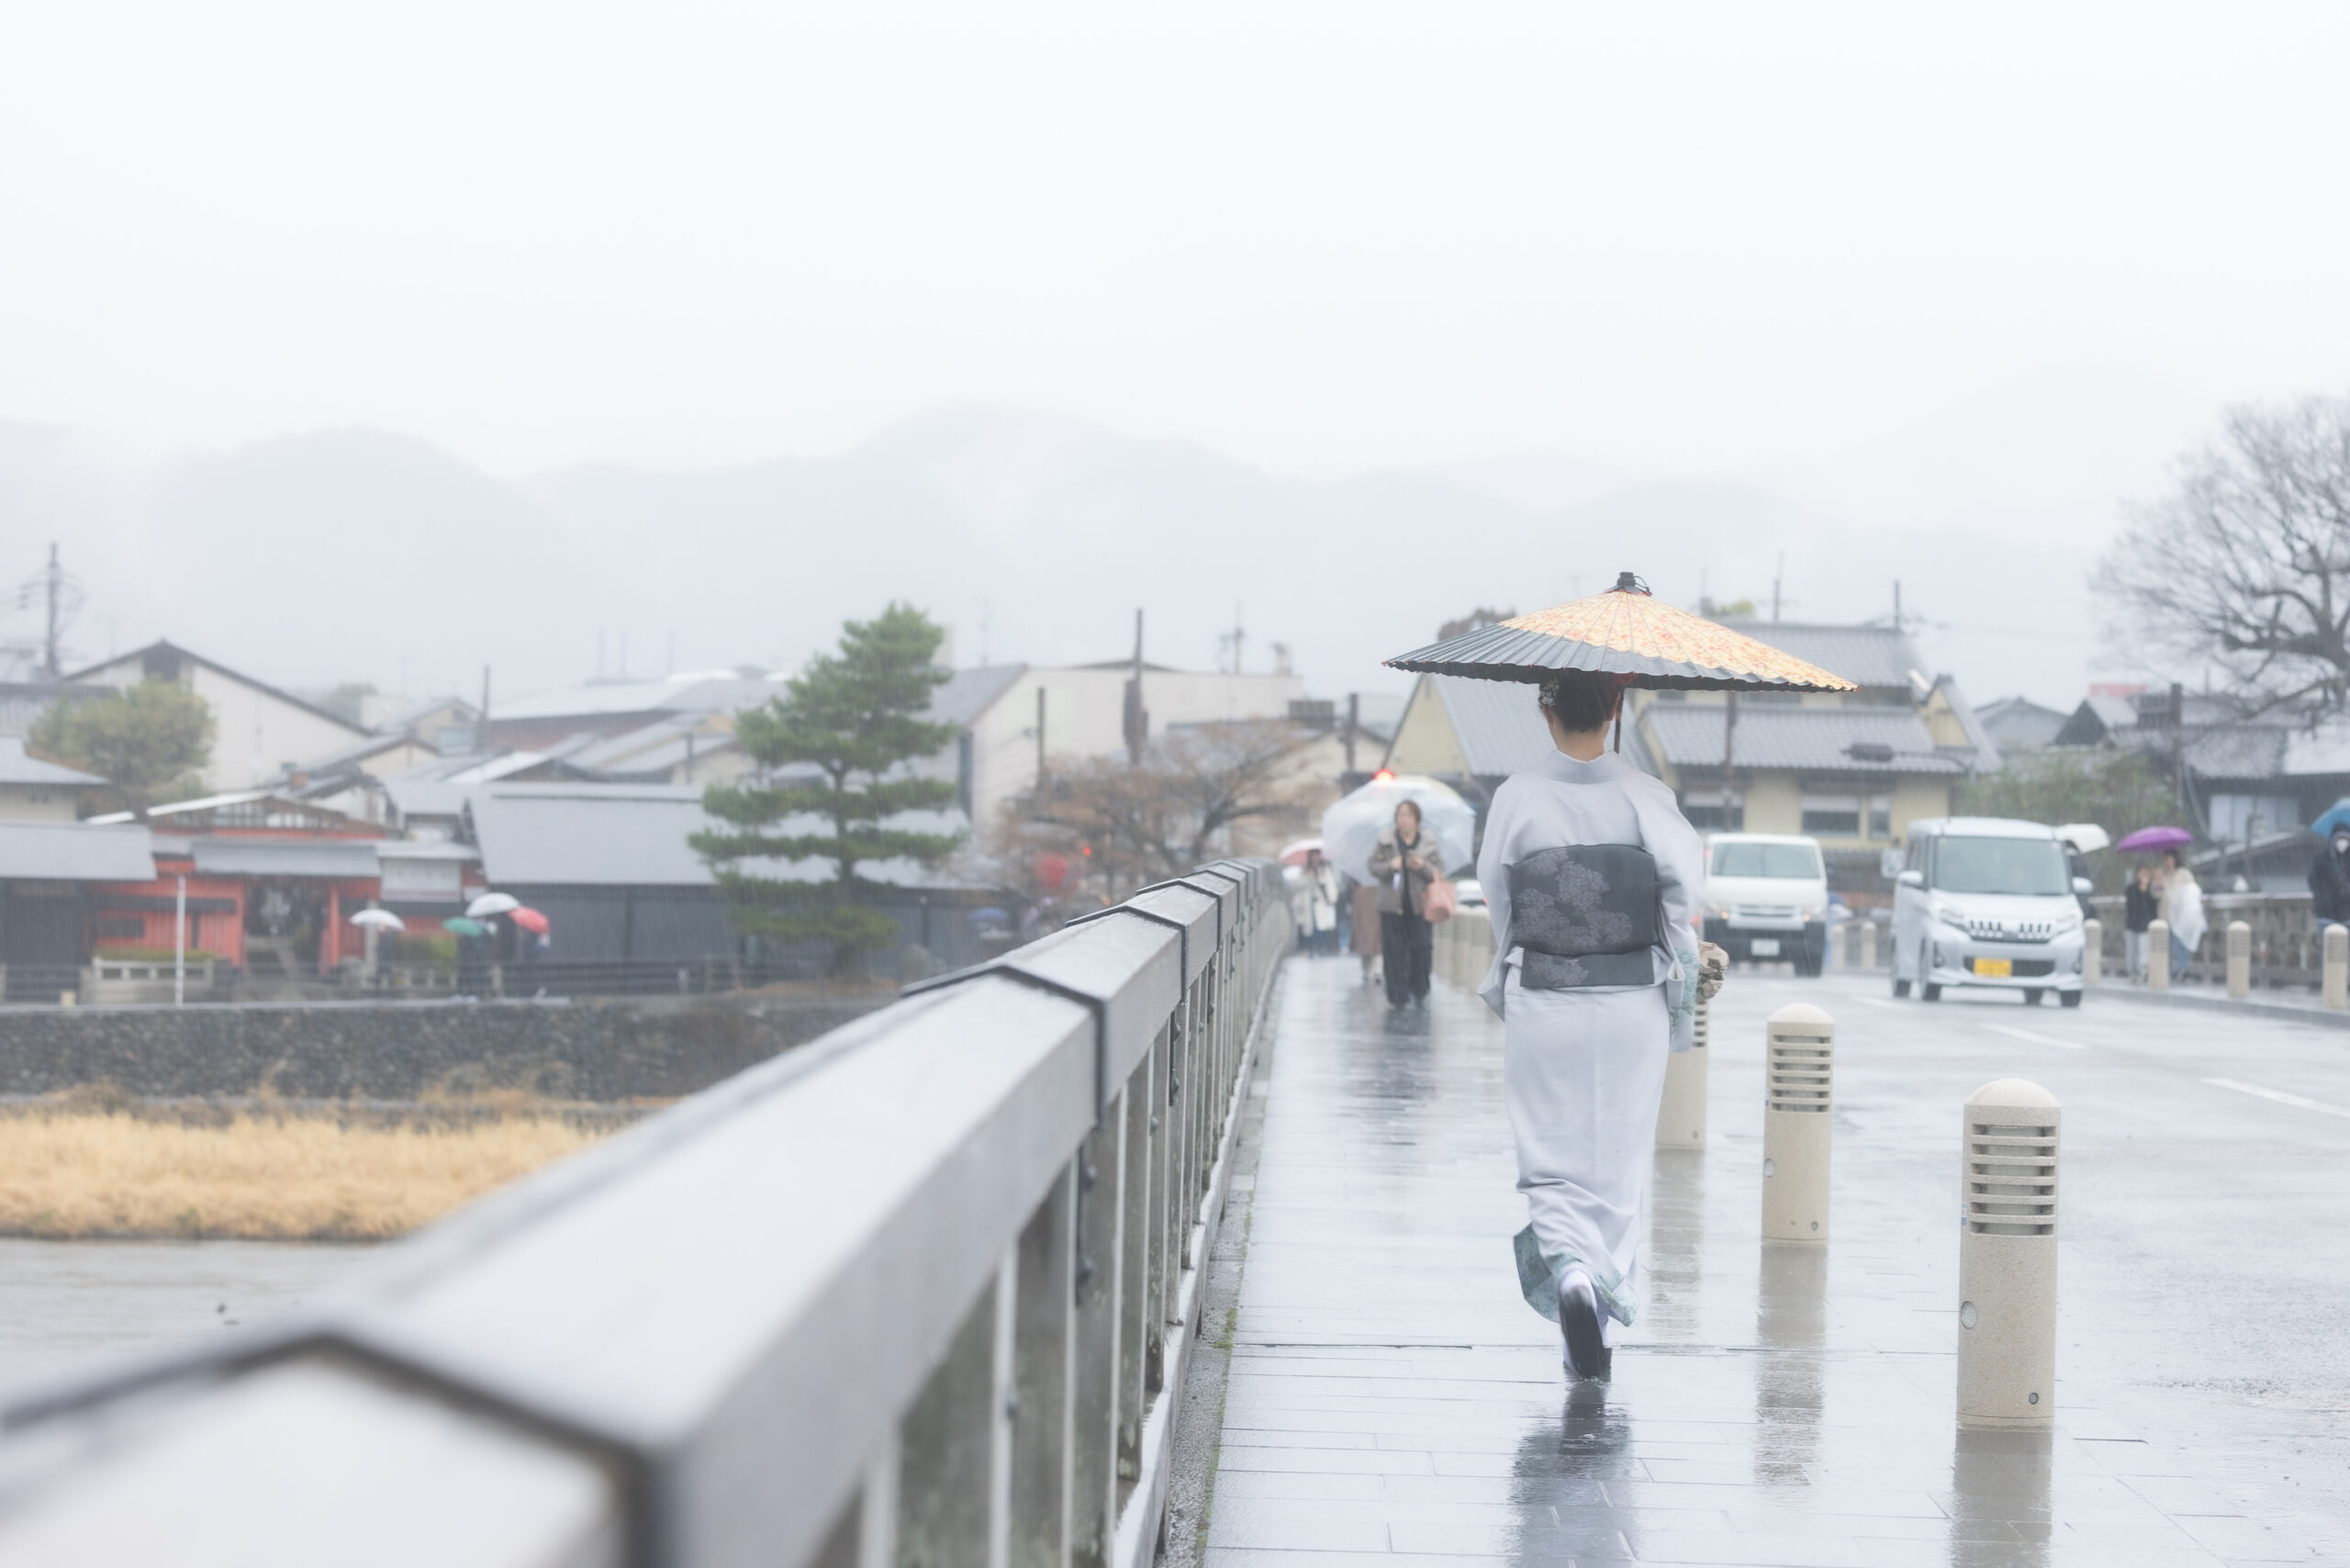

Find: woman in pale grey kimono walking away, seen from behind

[1478,670,1728,1378]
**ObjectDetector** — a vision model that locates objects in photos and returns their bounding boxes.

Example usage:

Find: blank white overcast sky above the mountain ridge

[0,0,2350,473]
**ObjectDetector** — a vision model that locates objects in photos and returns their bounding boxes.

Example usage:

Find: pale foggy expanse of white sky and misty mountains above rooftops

[0,5,2350,703]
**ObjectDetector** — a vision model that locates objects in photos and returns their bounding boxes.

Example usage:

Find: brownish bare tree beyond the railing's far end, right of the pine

[1015,722,1304,896]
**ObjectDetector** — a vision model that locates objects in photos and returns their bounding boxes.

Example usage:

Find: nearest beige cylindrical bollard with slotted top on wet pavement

[1957,1079,2061,1427]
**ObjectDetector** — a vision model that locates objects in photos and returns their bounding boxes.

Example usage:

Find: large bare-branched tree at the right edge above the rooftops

[2094,398,2350,712]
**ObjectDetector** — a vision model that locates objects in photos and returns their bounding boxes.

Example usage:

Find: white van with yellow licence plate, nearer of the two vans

[1894,816,2089,1006]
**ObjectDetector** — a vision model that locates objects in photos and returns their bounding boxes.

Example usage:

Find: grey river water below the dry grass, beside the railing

[0,1238,371,1399]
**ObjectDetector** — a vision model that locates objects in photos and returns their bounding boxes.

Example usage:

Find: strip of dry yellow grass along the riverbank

[0,1095,604,1241]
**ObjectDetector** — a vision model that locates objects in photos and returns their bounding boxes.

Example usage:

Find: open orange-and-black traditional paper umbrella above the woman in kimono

[1386,571,1856,691]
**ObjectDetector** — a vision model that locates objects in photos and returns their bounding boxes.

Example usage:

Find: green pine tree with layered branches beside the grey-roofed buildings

[693,602,961,959]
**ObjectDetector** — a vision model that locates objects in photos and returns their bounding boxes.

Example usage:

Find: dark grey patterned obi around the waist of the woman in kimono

[1509,844,1663,992]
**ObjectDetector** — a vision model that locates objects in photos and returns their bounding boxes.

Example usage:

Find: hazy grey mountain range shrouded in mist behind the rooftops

[0,376,2188,703]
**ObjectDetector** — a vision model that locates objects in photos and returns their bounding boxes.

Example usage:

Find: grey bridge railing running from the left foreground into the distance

[0,860,1292,1568]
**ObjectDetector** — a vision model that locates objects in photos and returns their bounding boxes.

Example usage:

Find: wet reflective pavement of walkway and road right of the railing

[1208,959,2350,1568]
